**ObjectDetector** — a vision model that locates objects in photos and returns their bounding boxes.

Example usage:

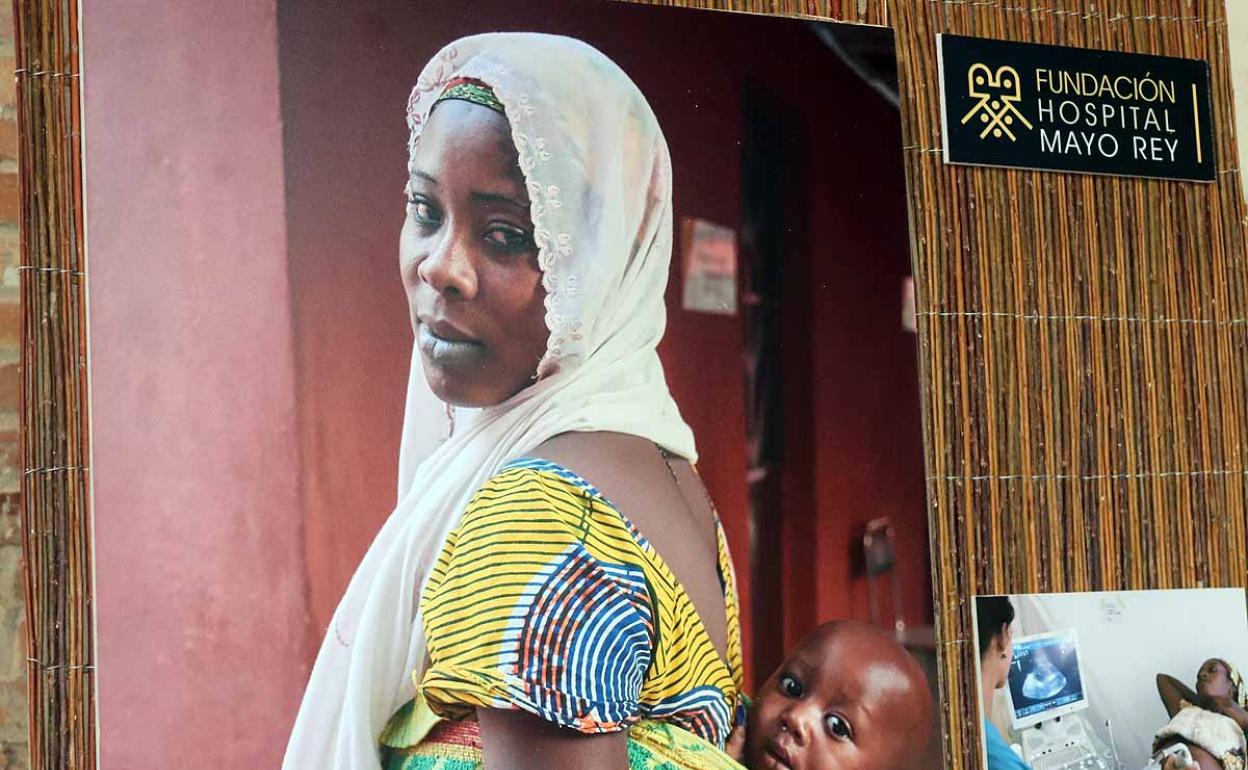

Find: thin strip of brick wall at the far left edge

[0,0,30,770]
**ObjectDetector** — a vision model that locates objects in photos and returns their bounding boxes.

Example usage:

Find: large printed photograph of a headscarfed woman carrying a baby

[84,0,938,770]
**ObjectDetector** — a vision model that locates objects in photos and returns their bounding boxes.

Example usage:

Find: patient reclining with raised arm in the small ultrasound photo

[1153,658,1248,770]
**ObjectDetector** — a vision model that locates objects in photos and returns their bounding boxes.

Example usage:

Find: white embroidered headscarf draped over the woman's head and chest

[283,34,696,770]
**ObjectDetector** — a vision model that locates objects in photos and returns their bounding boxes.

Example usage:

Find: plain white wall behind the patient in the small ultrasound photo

[1011,589,1248,770]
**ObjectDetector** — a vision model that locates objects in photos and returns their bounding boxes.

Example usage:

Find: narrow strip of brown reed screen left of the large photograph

[14,0,95,770]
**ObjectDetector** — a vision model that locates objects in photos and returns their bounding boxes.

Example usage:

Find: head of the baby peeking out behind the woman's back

[745,621,931,770]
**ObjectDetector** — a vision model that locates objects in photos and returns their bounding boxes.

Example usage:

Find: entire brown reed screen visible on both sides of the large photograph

[15,0,1248,770]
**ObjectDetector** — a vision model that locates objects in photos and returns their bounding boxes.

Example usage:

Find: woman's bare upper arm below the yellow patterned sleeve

[477,709,628,770]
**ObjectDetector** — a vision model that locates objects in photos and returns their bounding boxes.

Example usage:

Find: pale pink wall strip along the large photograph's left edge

[82,0,317,770]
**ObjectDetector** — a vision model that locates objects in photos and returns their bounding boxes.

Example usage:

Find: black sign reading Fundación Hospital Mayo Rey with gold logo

[938,35,1216,182]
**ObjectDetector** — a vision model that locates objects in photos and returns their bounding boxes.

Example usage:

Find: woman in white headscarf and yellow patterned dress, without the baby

[283,34,743,770]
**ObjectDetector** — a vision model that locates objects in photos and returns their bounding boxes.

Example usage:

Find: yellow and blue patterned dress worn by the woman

[381,458,745,770]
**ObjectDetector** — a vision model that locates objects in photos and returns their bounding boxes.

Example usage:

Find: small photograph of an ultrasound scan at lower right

[975,588,1248,770]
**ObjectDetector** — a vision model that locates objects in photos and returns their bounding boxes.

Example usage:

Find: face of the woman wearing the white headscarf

[399,100,549,407]
